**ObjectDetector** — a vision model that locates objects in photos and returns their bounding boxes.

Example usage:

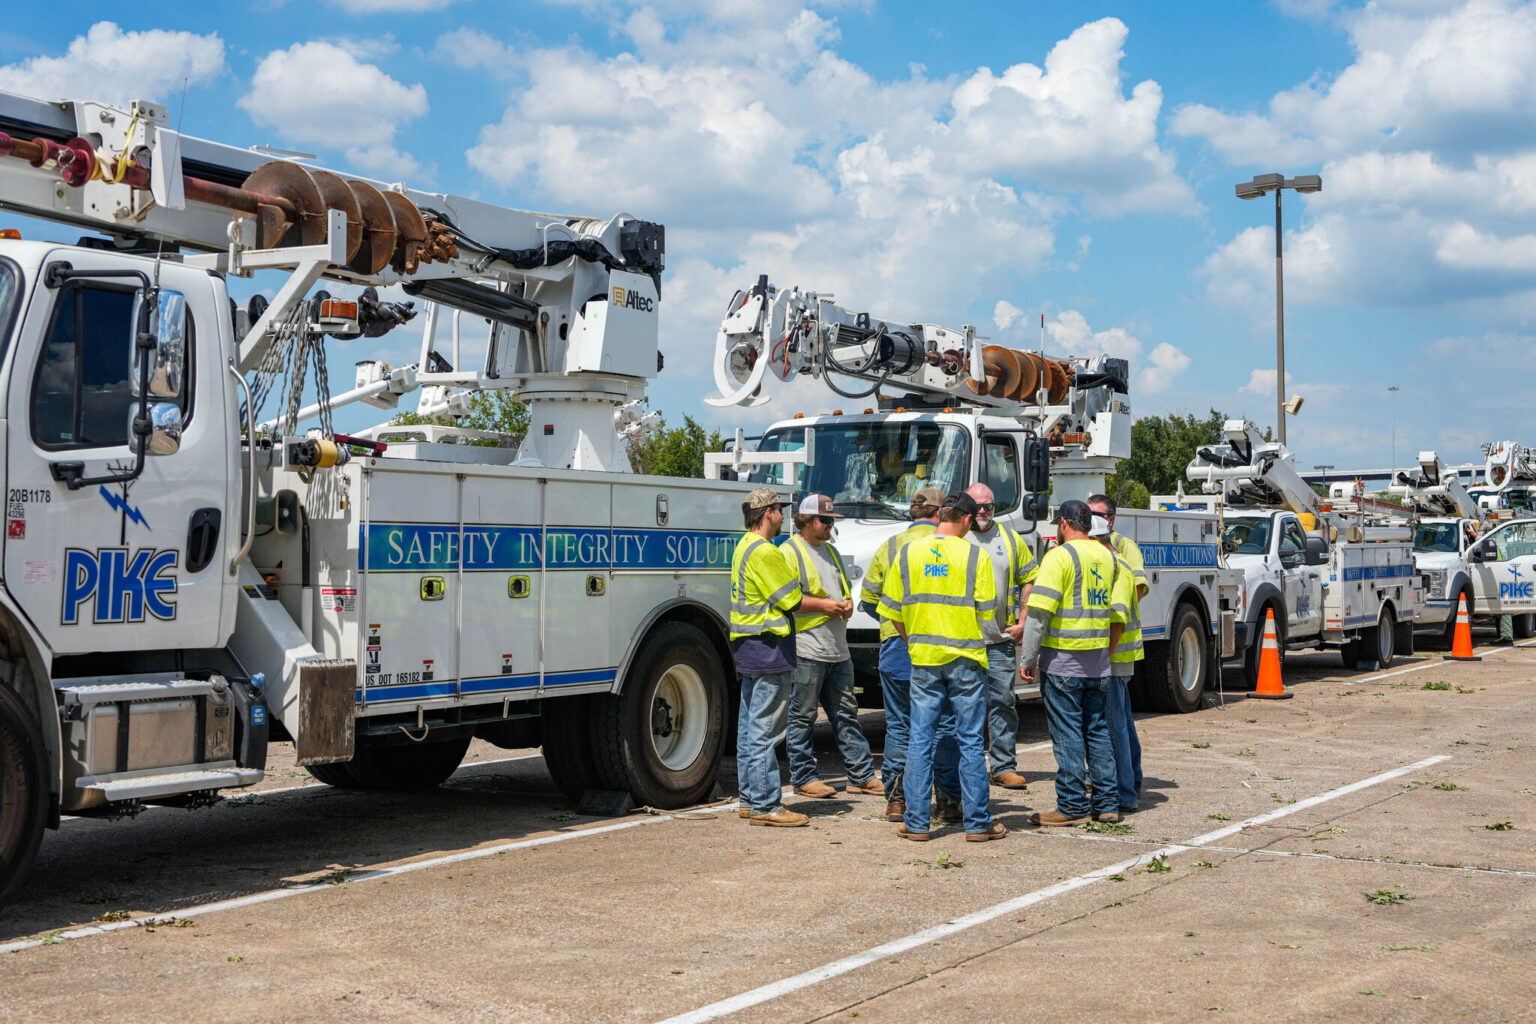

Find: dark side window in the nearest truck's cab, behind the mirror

[32,284,192,448]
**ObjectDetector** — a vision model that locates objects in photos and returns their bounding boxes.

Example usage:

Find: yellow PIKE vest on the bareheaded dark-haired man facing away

[880,536,997,668]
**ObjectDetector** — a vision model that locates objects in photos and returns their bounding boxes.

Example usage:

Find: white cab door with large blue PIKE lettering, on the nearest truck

[5,249,240,654]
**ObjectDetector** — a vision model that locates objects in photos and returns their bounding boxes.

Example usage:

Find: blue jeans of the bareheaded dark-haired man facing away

[906,657,992,832]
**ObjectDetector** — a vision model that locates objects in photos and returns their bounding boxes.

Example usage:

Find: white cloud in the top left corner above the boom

[0,21,224,104]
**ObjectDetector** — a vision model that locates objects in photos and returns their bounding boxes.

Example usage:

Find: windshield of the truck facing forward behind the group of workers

[751,421,971,519]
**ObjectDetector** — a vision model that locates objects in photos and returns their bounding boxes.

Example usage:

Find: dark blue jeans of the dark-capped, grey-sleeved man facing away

[1040,672,1120,818]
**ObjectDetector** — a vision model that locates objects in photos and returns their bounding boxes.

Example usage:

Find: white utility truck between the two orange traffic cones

[1173,419,1424,685]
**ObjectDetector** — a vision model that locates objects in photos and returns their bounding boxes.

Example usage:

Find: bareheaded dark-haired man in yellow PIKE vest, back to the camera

[880,493,1008,841]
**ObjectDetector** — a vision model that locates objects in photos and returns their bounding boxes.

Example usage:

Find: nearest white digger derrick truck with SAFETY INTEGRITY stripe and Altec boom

[0,94,748,901]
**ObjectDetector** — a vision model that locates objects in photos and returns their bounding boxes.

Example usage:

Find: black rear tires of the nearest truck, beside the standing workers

[591,622,727,809]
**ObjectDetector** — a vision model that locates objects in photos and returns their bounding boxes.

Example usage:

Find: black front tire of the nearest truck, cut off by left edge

[0,685,49,906]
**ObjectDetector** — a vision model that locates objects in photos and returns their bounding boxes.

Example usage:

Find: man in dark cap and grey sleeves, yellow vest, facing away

[1018,499,1127,824]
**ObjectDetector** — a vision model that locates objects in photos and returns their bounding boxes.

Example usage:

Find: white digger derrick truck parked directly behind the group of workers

[708,278,1241,711]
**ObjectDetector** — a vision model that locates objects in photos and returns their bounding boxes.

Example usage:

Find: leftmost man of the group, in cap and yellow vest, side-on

[731,487,837,827]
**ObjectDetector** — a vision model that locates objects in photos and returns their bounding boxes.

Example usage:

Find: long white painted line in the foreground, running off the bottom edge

[659,754,1450,1024]
